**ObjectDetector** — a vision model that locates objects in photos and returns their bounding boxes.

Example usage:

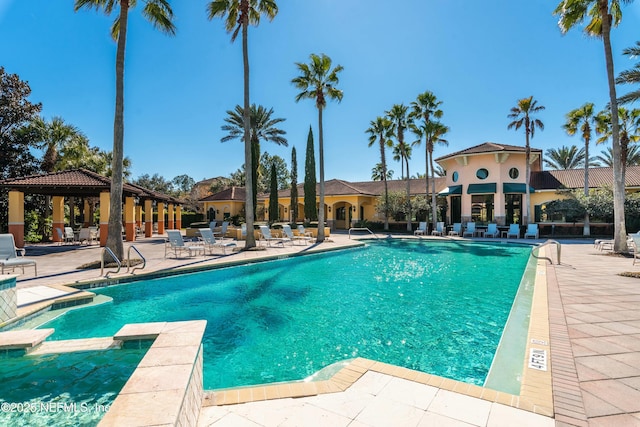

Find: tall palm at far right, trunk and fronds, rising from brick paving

[553,0,633,252]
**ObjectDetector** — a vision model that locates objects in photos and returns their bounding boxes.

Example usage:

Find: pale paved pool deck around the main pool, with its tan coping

[1,234,640,426]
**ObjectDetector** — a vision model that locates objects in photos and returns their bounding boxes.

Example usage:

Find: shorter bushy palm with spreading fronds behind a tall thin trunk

[220,104,288,212]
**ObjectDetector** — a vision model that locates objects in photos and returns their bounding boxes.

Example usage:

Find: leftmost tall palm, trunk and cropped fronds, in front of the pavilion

[74,0,176,259]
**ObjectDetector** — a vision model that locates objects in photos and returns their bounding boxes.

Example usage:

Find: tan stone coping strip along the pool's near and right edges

[202,248,555,417]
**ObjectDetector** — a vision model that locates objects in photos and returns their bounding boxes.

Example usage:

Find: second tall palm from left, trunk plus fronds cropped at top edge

[207,0,278,249]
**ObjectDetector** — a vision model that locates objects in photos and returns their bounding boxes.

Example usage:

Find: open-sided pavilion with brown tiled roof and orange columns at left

[0,169,184,246]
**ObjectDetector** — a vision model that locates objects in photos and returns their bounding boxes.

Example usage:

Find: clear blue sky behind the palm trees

[0,0,640,181]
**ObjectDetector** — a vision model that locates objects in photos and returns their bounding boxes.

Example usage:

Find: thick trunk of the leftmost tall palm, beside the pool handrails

[106,0,129,260]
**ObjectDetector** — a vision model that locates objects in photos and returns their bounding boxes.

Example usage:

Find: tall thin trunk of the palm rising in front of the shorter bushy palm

[240,0,256,249]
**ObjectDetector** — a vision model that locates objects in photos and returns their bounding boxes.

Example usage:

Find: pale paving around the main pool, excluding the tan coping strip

[5,234,640,426]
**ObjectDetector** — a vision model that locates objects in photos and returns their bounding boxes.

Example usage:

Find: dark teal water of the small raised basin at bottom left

[0,348,147,427]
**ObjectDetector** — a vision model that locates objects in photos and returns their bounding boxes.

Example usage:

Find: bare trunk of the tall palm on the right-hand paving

[598,0,627,252]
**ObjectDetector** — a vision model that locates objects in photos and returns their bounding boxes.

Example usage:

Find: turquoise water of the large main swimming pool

[44,239,530,389]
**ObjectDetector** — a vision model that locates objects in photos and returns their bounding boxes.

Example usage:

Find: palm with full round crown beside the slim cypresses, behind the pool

[291,53,343,243]
